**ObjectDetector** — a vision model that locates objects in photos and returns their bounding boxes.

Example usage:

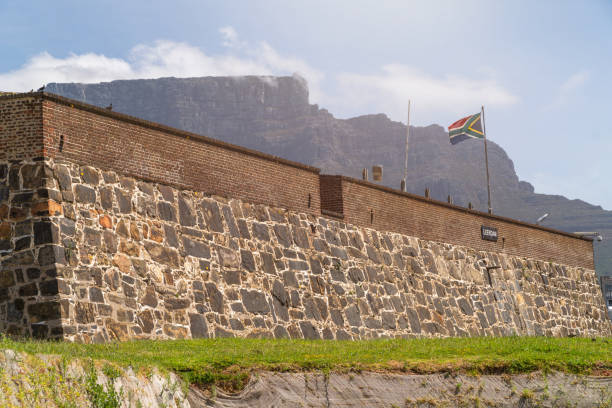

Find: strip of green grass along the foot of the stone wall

[0,337,612,389]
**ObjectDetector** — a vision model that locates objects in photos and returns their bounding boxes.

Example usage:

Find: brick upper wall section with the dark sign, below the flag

[338,177,594,269]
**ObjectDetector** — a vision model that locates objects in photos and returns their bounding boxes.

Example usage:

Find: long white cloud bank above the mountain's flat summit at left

[0,27,323,97]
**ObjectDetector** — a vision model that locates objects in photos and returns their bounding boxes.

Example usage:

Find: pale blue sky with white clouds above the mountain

[0,0,612,210]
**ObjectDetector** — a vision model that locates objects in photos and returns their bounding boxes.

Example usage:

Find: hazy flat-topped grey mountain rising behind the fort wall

[46,76,612,274]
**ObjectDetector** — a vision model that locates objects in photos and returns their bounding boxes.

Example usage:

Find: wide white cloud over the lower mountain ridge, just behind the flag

[330,64,518,123]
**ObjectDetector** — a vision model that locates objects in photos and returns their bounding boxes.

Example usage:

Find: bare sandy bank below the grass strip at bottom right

[188,373,612,408]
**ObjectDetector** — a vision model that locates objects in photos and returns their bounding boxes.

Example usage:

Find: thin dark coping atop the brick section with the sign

[334,175,593,243]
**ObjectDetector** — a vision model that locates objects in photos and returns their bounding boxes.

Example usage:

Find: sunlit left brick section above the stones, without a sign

[43,95,320,214]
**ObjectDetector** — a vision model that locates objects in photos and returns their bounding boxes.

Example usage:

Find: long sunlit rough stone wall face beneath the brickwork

[49,163,610,341]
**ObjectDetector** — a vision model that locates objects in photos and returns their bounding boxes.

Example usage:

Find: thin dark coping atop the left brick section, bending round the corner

[0,92,321,174]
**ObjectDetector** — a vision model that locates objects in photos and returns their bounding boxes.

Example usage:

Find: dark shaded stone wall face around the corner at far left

[0,160,63,337]
